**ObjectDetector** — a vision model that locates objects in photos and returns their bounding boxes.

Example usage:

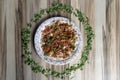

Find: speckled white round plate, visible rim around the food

[34,17,83,65]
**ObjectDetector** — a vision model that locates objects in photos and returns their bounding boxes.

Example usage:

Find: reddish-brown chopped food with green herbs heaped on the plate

[42,20,78,60]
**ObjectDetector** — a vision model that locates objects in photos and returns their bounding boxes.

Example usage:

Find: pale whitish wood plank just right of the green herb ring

[95,0,106,80]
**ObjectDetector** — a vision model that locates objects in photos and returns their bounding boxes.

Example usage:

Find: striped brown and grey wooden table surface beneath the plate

[0,0,120,80]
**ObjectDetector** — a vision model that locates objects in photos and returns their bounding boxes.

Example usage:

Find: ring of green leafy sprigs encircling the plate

[21,4,94,78]
